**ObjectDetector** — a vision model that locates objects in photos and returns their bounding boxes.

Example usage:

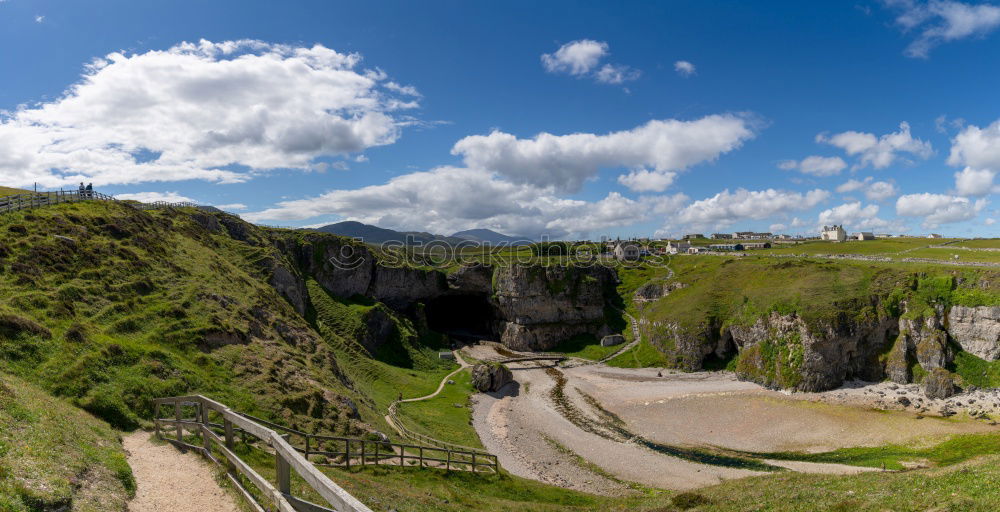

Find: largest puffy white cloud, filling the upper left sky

[0,40,417,187]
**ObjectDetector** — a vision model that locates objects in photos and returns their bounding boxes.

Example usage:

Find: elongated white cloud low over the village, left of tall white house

[677,188,830,229]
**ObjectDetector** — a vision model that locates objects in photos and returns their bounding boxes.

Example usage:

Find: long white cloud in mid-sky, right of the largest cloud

[451,115,754,192]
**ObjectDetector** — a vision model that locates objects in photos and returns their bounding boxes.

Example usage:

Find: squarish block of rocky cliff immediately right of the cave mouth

[493,265,617,350]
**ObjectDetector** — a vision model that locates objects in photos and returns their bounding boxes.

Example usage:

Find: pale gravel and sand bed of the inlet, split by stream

[464,346,1000,495]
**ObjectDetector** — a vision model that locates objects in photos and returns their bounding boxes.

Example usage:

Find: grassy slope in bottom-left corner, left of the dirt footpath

[0,373,135,512]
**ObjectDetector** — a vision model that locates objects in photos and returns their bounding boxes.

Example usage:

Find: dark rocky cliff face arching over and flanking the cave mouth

[265,234,617,350]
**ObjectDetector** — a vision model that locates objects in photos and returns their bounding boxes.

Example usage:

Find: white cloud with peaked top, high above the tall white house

[816,122,934,169]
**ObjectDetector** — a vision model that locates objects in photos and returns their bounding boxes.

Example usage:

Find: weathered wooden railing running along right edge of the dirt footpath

[153,395,371,512]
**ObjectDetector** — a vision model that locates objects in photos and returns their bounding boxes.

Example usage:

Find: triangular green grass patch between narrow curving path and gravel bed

[397,370,483,448]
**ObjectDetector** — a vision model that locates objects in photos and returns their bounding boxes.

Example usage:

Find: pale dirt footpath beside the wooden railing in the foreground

[124,431,239,512]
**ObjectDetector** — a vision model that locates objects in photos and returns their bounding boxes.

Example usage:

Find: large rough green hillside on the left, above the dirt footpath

[0,199,447,435]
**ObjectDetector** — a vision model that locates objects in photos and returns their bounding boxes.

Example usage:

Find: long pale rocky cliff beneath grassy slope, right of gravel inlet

[640,294,976,391]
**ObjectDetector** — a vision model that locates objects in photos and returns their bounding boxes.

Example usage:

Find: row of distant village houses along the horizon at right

[601,225,941,261]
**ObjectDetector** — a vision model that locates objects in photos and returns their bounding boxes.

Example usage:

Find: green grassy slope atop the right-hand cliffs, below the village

[611,254,1000,378]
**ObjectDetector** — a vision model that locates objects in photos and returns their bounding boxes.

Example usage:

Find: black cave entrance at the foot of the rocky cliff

[424,295,494,341]
